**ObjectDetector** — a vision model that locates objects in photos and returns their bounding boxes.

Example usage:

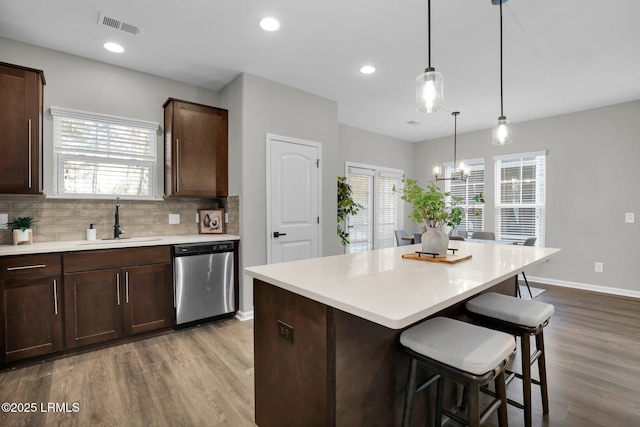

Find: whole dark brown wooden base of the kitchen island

[254,277,516,427]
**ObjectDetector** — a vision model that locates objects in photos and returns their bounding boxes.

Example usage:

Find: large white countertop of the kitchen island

[245,241,560,329]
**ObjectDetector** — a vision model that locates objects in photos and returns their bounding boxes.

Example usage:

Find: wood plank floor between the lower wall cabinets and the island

[0,319,255,427]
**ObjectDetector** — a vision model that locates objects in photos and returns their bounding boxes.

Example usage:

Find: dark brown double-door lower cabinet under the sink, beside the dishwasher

[64,247,174,348]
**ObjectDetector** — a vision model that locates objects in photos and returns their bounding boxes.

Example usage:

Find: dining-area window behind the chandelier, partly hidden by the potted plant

[445,159,485,231]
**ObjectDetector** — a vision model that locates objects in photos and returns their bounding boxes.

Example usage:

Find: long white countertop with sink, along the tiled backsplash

[0,234,240,256]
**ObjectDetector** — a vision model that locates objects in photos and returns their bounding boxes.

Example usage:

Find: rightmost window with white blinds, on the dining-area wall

[494,152,546,246]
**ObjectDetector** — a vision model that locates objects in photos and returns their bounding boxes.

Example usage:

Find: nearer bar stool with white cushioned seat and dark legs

[400,317,516,427]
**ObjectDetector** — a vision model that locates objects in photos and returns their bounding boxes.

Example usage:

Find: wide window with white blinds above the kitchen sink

[51,107,159,199]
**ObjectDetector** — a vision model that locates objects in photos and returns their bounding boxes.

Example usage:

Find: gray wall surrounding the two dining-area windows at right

[415,101,640,296]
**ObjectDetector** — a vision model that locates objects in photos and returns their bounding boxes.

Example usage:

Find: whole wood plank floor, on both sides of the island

[0,284,640,427]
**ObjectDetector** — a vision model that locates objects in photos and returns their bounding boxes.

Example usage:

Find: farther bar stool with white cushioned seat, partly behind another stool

[466,292,554,427]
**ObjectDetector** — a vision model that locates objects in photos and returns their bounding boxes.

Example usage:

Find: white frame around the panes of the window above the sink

[48,106,162,201]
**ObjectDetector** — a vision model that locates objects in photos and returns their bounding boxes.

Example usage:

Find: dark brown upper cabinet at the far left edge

[0,62,45,194]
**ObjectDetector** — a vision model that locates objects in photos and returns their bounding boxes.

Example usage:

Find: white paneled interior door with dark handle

[267,135,322,263]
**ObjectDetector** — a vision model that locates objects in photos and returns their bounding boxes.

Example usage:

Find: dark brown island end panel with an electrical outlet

[253,280,335,427]
